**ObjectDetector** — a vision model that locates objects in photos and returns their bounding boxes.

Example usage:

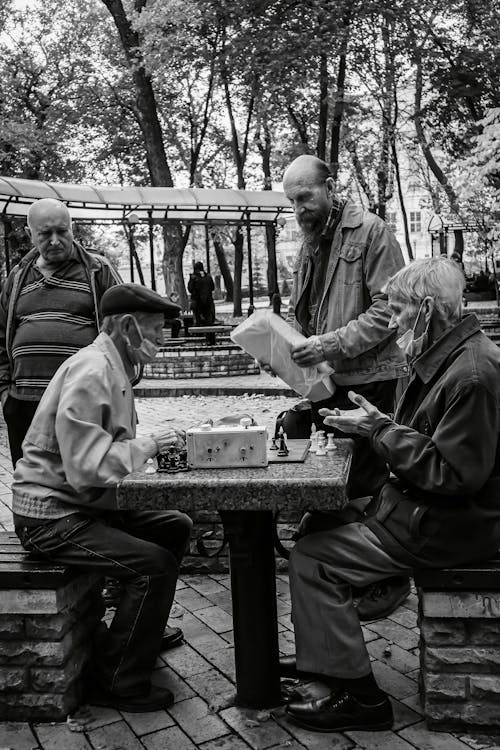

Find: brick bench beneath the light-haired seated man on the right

[415,559,500,732]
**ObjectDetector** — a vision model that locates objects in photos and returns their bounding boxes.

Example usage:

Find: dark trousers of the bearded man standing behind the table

[282,380,397,500]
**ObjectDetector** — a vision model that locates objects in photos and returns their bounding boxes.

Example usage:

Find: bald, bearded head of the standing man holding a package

[283,154,334,234]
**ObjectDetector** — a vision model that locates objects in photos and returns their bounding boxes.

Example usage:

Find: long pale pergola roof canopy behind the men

[0,177,292,225]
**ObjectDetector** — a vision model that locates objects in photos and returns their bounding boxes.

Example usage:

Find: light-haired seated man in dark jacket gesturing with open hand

[287,257,500,731]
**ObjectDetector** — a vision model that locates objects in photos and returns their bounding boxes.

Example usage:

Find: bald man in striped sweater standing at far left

[0,198,121,466]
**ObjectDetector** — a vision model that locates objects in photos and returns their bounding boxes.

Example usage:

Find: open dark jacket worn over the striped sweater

[0,242,122,395]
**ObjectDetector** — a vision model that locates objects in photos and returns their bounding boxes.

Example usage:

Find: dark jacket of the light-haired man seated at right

[366,315,500,567]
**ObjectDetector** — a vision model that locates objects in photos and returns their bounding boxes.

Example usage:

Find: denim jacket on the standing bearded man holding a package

[287,201,408,385]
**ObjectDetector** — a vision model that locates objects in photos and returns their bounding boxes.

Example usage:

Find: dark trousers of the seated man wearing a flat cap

[16,511,192,696]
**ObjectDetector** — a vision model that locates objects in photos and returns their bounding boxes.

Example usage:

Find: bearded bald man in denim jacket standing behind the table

[283,156,410,620]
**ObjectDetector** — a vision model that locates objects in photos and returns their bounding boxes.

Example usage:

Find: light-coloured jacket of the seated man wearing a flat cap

[12,333,157,518]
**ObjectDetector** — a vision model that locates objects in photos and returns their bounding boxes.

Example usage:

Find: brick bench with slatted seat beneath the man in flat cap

[0,532,104,721]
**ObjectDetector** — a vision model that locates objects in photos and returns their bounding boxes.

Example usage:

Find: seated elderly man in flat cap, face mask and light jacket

[12,284,192,712]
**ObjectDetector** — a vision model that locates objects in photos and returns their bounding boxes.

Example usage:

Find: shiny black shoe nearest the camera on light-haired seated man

[286,691,394,732]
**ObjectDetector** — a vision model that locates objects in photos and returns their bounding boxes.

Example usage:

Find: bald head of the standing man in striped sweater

[27,198,73,269]
